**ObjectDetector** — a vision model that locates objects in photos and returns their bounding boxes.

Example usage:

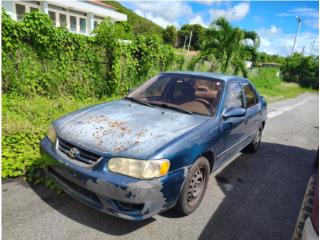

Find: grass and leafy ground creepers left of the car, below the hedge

[2,94,115,191]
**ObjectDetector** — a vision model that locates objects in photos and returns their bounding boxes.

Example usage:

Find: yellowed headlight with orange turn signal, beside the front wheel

[108,158,170,179]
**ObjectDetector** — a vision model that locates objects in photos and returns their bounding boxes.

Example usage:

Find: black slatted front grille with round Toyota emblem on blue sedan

[58,138,101,164]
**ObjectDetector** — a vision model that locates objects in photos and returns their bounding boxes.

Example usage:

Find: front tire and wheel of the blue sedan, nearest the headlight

[175,157,210,216]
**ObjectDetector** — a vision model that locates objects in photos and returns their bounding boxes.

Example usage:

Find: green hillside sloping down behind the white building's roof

[104,1,163,35]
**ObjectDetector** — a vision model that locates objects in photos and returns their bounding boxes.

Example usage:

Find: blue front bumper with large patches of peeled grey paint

[41,138,188,220]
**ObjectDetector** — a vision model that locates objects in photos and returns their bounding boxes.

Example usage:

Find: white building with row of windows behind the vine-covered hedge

[2,0,127,34]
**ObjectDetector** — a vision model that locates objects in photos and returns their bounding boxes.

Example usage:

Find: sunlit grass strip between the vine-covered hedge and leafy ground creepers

[2,94,119,135]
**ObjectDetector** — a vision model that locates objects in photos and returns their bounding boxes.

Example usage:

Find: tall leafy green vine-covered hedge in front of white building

[2,11,181,99]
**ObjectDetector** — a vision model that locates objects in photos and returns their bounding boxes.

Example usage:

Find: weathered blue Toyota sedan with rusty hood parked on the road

[41,72,267,220]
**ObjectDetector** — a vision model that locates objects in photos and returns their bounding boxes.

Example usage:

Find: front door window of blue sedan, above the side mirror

[225,82,244,109]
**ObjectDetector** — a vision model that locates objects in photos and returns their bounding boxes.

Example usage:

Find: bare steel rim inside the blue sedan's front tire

[187,168,206,206]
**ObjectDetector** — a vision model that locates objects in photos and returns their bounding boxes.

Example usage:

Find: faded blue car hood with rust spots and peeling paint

[54,100,209,158]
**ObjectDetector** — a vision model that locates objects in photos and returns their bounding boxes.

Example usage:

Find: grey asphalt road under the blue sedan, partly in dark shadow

[2,94,319,240]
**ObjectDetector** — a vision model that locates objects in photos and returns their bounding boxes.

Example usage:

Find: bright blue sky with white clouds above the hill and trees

[120,0,319,56]
